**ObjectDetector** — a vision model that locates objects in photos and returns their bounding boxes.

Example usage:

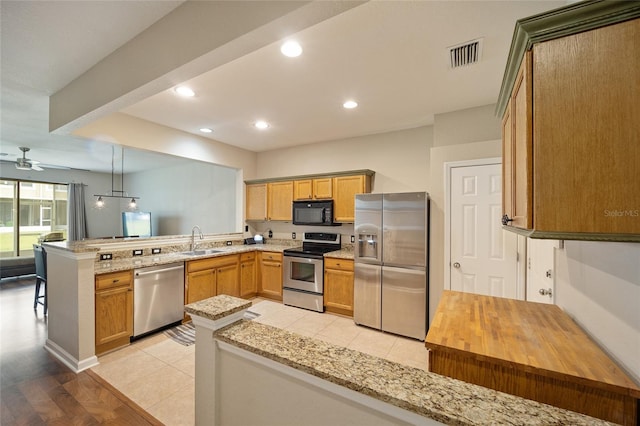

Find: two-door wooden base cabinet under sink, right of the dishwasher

[185,254,240,304]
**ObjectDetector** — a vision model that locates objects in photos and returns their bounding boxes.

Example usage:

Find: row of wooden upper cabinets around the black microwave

[245,170,374,223]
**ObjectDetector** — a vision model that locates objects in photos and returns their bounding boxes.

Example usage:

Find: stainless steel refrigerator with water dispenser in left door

[353,192,429,340]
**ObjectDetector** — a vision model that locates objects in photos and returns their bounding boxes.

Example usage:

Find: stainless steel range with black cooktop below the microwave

[282,232,340,312]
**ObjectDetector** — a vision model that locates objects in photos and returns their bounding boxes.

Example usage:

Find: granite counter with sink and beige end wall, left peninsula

[45,233,328,372]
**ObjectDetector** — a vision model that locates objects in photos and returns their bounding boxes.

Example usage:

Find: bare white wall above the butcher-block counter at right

[555,241,640,383]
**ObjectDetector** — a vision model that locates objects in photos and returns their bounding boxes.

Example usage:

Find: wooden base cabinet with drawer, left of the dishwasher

[95,271,133,355]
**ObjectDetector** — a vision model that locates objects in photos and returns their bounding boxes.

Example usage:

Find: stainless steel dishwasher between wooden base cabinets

[133,262,184,338]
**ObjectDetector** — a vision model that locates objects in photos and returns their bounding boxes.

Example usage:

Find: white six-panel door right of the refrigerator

[449,164,518,299]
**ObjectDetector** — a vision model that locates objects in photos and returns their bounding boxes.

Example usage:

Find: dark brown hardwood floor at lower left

[0,277,162,425]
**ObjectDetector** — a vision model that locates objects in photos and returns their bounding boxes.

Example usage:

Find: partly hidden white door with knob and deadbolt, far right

[527,238,557,304]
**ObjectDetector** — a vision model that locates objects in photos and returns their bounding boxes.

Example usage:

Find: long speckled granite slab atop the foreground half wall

[216,320,611,426]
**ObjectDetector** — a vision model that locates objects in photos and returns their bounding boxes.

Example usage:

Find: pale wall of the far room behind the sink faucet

[125,161,236,235]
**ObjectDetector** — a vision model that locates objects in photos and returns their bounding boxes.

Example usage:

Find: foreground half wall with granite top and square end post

[185,296,610,425]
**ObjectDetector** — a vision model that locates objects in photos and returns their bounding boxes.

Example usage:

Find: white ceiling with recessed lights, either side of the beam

[0,0,565,171]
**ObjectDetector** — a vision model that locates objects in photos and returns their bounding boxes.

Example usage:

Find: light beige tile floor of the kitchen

[92,299,428,426]
